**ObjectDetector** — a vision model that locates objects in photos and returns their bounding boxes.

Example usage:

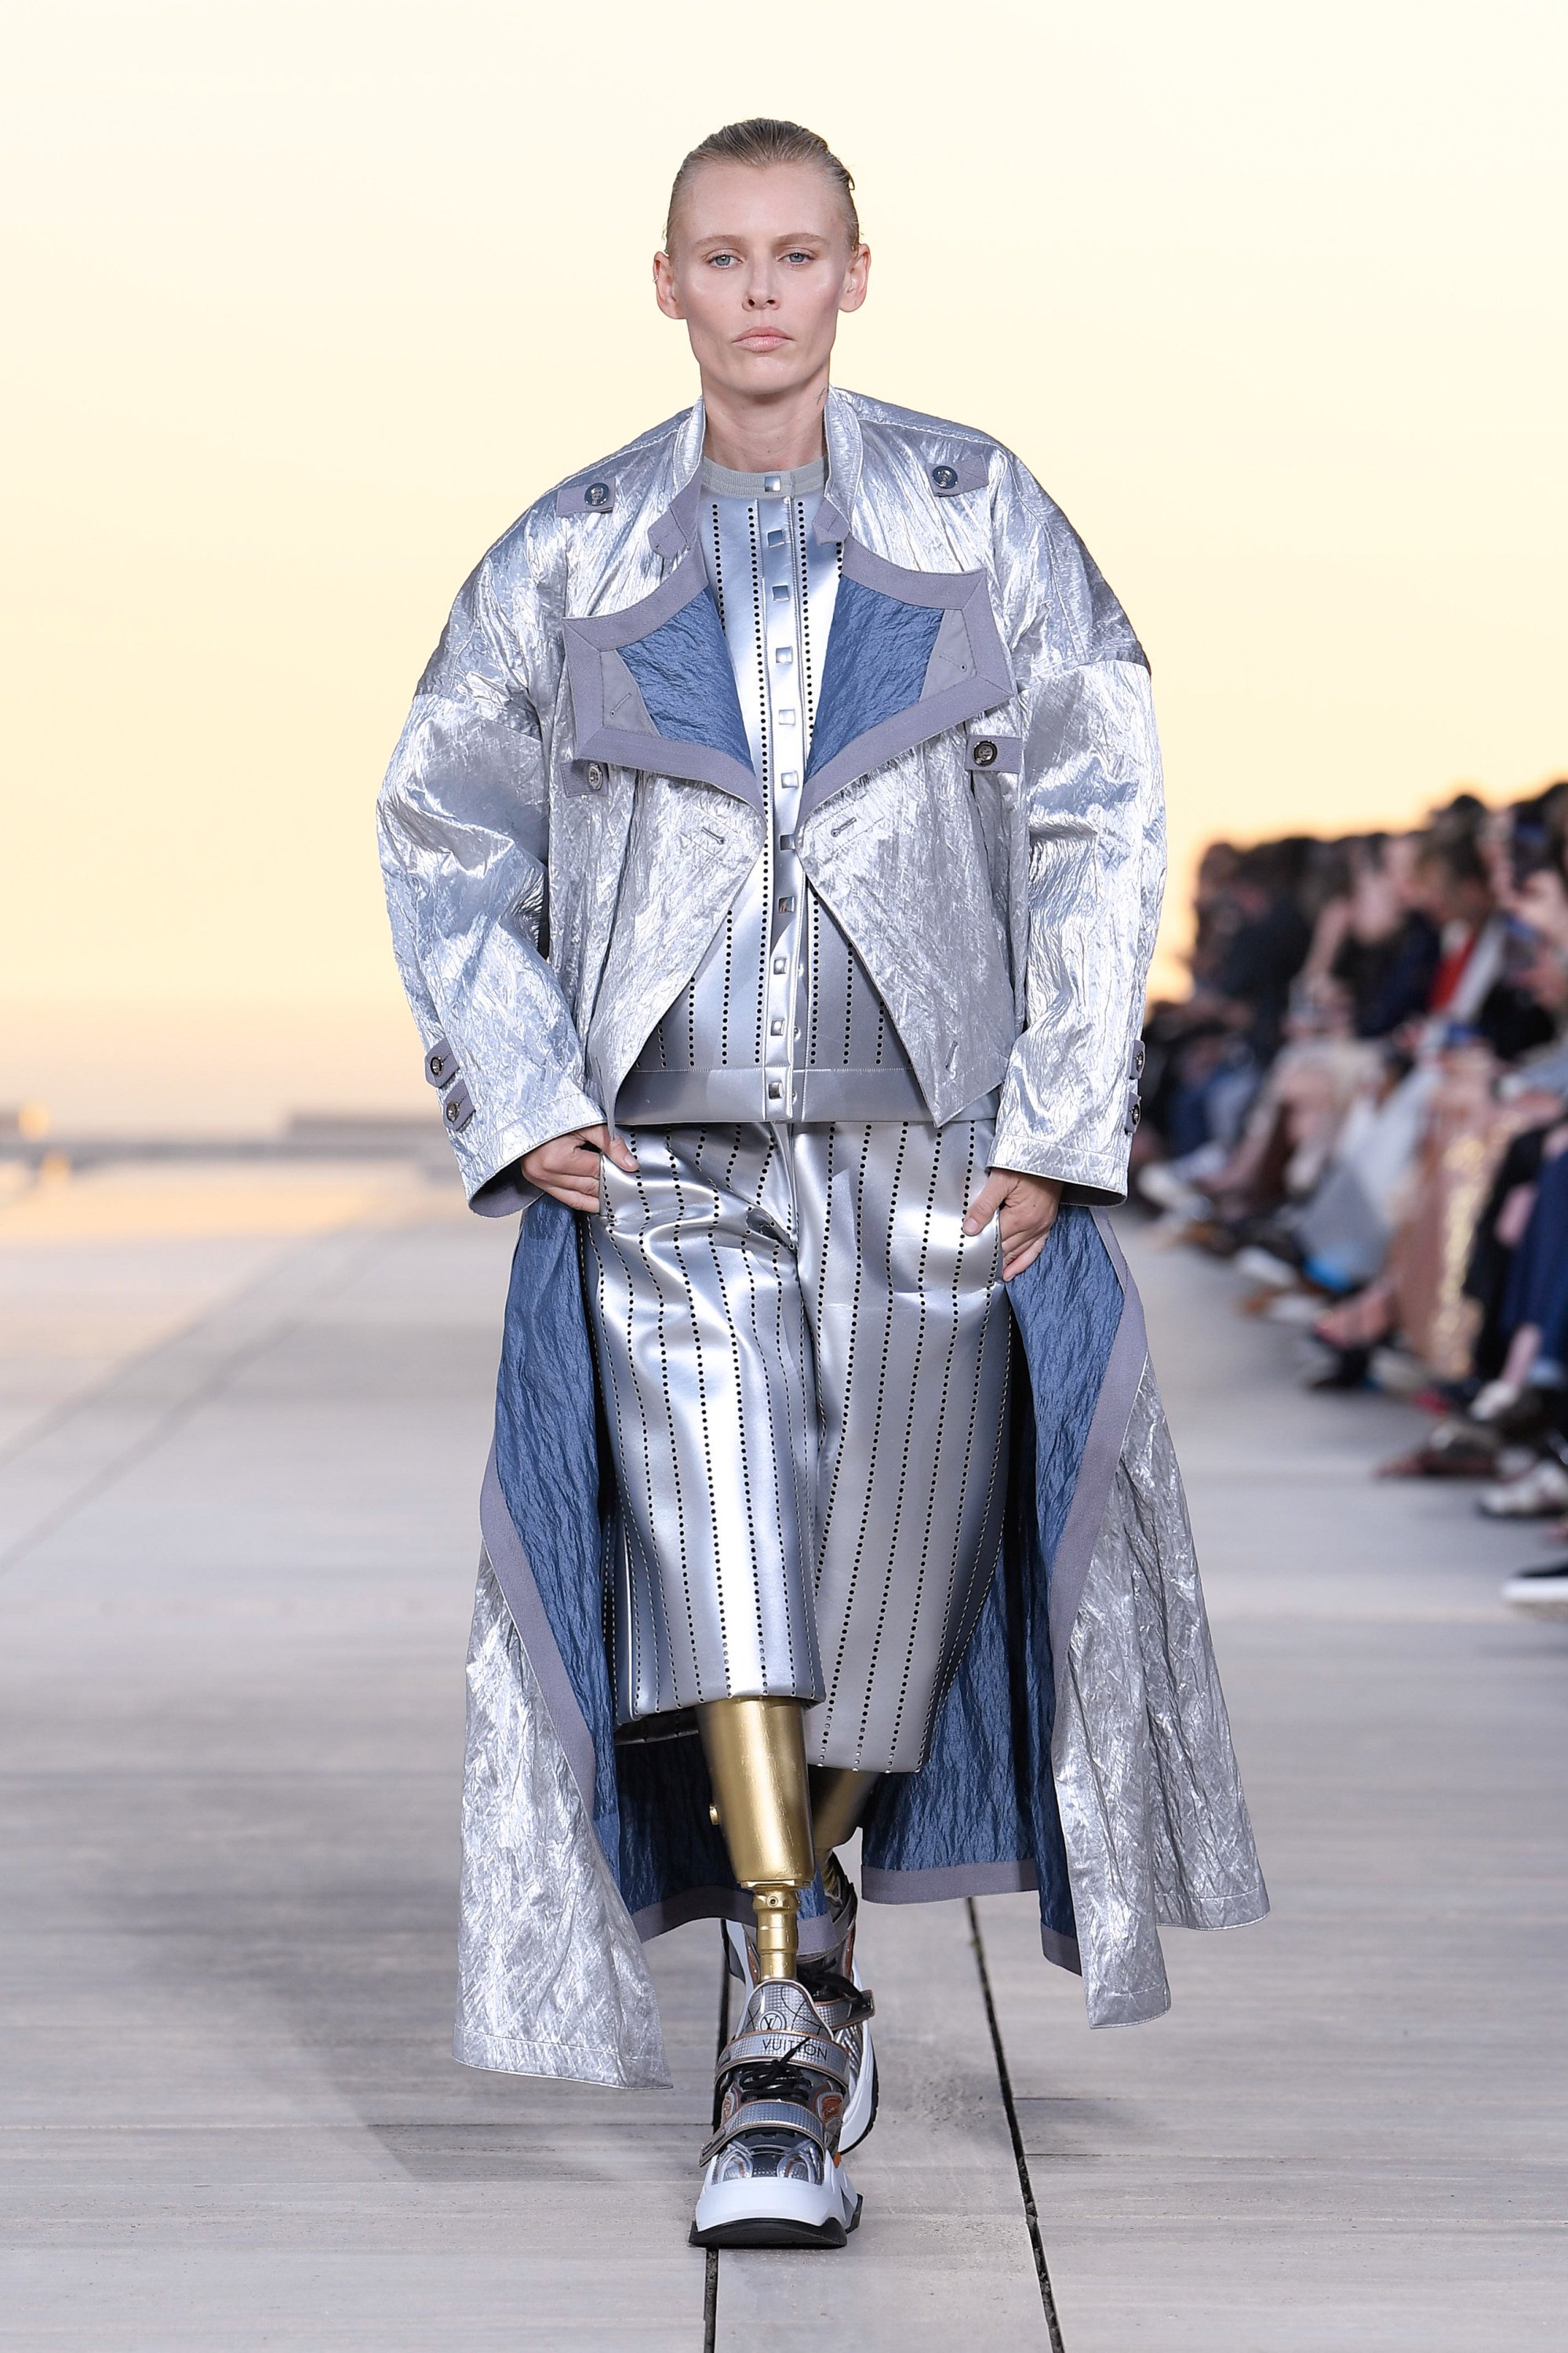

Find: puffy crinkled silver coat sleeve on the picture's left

[379,558,604,1216]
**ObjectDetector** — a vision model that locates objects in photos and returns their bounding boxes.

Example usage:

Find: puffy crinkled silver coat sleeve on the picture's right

[992,461,1166,1202]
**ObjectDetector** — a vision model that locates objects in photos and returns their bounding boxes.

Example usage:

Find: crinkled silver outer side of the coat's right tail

[1051,1362,1269,2026]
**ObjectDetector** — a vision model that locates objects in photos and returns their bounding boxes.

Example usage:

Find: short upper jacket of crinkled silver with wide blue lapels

[381,391,1164,1214]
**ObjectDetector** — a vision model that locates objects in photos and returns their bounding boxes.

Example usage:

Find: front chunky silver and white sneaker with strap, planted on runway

[691,1976,860,2247]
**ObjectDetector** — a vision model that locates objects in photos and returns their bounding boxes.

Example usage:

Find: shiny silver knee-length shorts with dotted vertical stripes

[585,1120,1011,1772]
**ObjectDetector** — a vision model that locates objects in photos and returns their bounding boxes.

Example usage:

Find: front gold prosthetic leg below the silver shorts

[696,1699,816,1976]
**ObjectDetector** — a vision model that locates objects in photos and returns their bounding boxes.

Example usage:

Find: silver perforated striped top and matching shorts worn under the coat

[585,468,1011,1772]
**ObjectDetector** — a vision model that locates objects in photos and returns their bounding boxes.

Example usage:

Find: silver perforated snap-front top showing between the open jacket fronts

[616,464,926,1127]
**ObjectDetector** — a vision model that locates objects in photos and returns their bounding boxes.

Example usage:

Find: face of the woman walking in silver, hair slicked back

[653,162,872,400]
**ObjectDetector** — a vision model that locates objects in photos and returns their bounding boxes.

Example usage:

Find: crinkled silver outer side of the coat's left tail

[453,1557,670,2089]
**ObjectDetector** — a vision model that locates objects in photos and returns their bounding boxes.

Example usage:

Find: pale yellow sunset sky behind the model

[0,0,1568,1127]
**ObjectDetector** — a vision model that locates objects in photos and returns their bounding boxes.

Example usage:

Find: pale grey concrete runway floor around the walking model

[0,1170,1568,2353]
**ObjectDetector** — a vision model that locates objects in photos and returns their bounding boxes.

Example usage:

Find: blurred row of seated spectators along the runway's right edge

[1133,781,1568,1612]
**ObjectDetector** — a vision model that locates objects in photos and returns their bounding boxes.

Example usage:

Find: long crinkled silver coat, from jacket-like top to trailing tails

[381,393,1267,2085]
